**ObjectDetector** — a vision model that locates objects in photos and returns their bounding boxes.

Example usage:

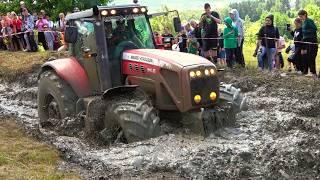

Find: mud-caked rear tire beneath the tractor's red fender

[38,71,78,127]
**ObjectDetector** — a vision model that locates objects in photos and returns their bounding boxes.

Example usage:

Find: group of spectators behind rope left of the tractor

[0,1,66,52]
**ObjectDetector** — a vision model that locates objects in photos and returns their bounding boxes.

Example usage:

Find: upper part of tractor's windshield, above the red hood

[104,15,155,49]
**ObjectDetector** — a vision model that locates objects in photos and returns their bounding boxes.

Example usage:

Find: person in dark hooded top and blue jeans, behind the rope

[258,15,280,71]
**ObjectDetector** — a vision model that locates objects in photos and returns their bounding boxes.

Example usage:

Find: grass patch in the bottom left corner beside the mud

[0,119,80,180]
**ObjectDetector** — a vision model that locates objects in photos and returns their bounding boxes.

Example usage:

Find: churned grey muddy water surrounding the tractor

[0,74,320,179]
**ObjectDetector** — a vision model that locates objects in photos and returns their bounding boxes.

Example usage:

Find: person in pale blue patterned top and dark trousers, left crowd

[22,8,38,52]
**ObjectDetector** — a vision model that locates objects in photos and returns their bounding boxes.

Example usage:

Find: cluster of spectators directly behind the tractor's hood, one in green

[154,3,245,68]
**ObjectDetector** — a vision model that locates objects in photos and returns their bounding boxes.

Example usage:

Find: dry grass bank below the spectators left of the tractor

[0,51,65,82]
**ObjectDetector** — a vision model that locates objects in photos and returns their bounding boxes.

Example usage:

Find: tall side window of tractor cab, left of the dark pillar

[72,20,101,94]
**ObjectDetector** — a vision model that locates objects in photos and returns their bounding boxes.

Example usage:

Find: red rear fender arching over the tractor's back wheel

[38,58,92,98]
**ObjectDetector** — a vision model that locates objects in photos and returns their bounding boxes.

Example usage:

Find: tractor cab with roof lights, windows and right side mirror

[65,4,181,94]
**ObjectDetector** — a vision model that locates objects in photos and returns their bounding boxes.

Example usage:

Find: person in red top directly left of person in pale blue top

[11,12,24,50]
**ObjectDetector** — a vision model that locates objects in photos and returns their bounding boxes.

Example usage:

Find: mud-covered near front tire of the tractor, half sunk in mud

[104,90,160,143]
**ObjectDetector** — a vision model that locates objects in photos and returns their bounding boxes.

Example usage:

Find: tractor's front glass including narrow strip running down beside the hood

[105,15,155,86]
